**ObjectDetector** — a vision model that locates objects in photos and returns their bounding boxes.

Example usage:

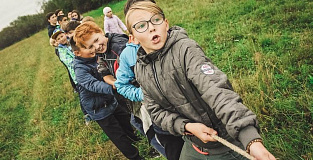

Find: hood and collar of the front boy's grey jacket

[137,26,188,65]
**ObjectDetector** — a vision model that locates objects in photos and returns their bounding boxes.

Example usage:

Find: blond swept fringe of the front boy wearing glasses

[125,0,165,34]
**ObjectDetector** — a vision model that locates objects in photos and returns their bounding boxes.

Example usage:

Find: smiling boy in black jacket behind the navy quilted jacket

[75,22,132,115]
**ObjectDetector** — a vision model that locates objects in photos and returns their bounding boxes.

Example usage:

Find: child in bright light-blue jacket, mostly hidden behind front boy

[114,36,183,160]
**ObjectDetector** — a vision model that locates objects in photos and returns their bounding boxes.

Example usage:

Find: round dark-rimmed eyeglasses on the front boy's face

[133,14,164,33]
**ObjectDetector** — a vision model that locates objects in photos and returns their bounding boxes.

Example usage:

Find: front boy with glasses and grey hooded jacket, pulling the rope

[126,2,275,160]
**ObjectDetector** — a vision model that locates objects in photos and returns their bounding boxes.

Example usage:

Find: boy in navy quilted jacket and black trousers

[74,24,142,160]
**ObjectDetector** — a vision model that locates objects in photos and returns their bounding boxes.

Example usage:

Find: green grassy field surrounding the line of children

[0,0,313,160]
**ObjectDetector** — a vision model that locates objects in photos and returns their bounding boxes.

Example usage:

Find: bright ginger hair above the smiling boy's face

[74,21,103,48]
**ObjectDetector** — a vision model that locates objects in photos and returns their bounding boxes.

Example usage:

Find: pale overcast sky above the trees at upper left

[0,0,45,31]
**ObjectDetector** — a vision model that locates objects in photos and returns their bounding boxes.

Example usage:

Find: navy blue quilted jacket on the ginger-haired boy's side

[74,56,118,120]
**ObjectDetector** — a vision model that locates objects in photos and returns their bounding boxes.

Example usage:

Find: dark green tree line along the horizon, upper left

[0,0,118,50]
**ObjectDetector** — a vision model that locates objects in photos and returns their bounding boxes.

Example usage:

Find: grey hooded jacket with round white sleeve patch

[135,27,260,152]
